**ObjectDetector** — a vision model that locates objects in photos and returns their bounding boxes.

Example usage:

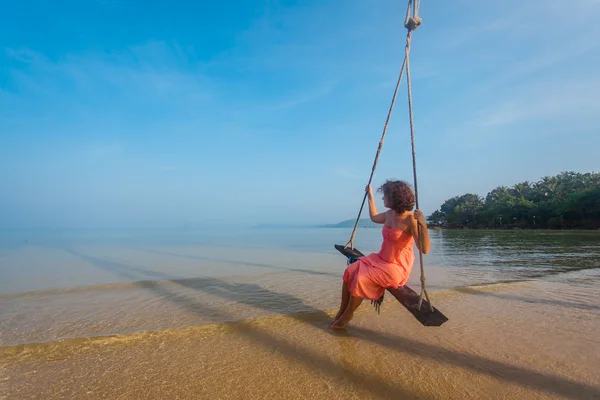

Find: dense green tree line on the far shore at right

[427,171,600,229]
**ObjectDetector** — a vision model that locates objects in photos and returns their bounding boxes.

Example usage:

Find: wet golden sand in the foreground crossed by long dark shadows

[0,277,600,399]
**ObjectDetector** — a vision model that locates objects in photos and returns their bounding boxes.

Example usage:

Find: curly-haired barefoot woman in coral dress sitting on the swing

[329,180,431,329]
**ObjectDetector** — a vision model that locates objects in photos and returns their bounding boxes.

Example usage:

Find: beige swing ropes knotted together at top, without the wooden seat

[345,0,433,312]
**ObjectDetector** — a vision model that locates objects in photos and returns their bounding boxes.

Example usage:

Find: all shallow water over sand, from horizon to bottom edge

[0,229,600,399]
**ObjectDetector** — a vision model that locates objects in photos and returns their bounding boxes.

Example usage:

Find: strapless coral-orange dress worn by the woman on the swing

[343,225,415,300]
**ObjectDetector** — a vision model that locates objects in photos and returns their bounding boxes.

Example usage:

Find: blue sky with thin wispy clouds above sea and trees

[0,0,600,228]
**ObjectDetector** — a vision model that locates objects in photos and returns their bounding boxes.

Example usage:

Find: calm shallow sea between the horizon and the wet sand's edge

[0,229,600,345]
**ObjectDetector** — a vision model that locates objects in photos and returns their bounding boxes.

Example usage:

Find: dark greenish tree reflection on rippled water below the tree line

[432,230,600,283]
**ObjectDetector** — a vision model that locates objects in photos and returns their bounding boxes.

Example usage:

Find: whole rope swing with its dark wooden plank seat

[334,0,448,326]
